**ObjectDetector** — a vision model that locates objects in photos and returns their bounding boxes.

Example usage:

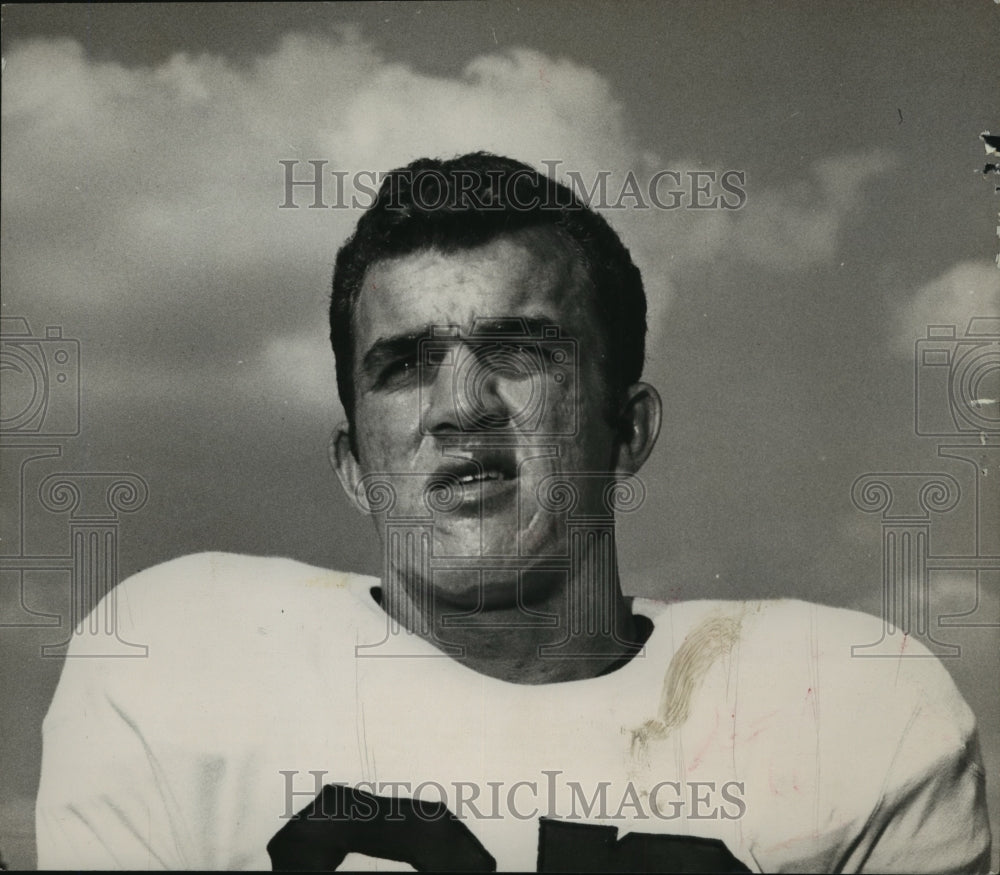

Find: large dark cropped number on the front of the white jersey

[267,784,750,873]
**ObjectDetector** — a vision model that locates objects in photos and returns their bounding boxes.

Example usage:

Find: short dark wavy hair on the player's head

[330,152,646,439]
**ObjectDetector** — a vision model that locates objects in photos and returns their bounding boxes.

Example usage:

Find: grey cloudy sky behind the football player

[0,0,1000,866]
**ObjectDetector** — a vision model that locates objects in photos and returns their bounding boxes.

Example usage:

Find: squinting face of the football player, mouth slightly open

[354,231,615,603]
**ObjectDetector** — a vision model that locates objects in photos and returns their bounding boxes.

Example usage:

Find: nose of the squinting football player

[423,342,511,433]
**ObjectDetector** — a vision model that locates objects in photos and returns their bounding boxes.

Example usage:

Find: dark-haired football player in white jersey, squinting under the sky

[37,153,990,872]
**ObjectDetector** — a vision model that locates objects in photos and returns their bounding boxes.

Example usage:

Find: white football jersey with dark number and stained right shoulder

[37,553,990,872]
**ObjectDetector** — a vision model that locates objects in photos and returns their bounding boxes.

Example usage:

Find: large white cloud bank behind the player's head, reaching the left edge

[3,29,900,414]
